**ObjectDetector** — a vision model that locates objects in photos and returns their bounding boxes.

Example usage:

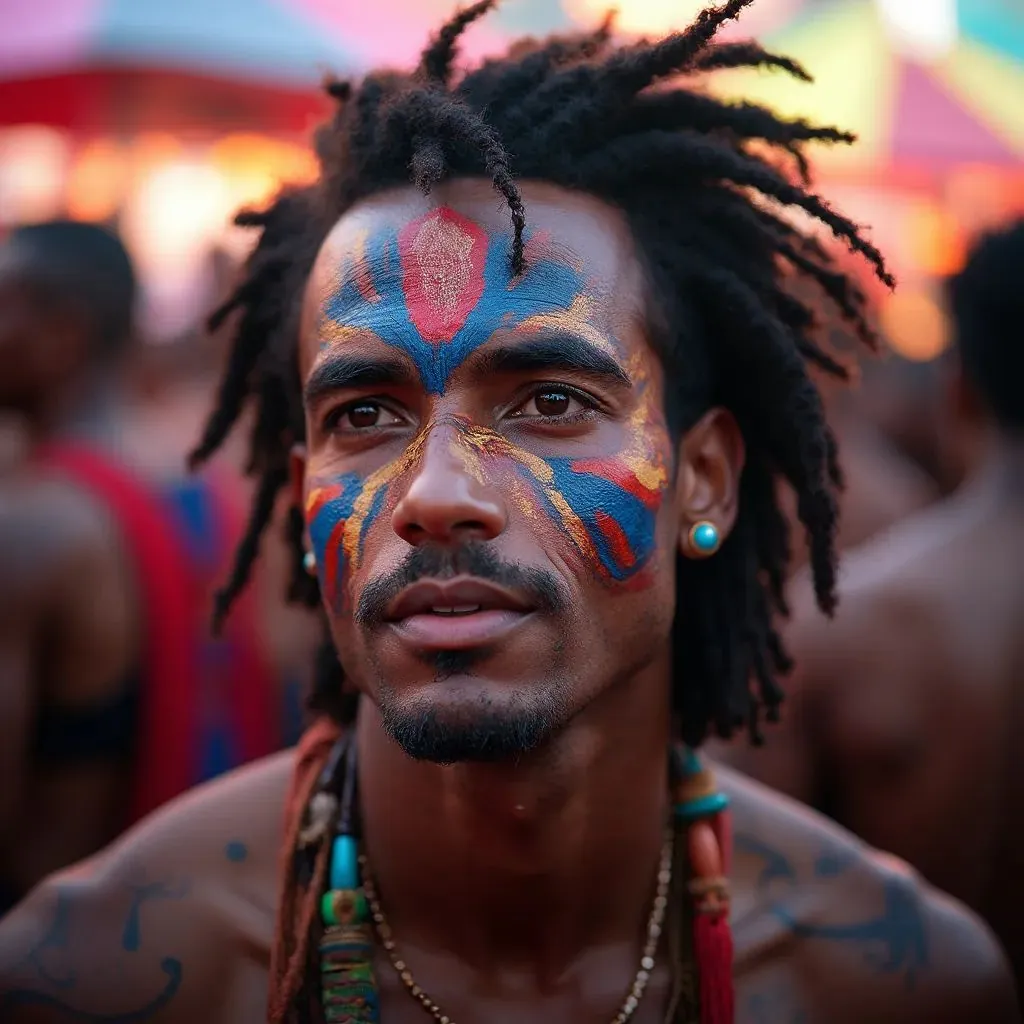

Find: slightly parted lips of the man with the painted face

[384,577,537,650]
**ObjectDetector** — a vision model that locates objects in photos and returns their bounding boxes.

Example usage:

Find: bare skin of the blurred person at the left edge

[0,260,139,901]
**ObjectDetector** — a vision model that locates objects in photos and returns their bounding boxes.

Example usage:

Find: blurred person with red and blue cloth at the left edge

[0,221,280,905]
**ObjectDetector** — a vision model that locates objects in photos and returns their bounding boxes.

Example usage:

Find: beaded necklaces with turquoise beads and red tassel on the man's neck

[300,735,734,1024]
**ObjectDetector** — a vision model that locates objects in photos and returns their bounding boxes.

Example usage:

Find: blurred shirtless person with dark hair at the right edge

[726,222,1024,980]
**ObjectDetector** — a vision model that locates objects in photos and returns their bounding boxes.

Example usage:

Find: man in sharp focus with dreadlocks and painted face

[0,0,1017,1024]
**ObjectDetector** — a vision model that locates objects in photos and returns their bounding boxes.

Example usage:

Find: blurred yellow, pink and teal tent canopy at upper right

[714,0,1024,175]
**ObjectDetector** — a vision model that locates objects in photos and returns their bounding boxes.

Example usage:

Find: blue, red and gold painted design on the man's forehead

[319,207,607,394]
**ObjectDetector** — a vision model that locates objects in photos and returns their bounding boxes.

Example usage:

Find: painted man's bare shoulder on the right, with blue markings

[721,770,1020,1024]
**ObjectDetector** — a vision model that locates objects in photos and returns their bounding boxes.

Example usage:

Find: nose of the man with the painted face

[391,424,508,545]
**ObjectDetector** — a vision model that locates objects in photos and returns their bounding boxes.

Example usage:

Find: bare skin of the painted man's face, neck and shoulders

[0,182,1017,1024]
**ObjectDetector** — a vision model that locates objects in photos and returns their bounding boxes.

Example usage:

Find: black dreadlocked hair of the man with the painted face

[191,0,893,743]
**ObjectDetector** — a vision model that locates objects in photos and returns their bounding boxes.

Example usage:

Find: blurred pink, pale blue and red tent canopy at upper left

[0,0,356,133]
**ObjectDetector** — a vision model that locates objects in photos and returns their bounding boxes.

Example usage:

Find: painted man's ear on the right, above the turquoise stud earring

[676,409,746,555]
